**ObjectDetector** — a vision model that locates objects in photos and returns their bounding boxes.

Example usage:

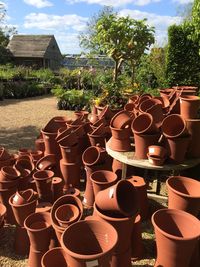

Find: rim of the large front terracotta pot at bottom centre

[60,219,118,260]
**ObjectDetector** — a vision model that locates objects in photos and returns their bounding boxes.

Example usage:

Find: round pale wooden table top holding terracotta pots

[106,141,200,171]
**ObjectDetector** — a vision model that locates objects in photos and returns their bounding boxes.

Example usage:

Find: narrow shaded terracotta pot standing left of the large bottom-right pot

[131,215,144,261]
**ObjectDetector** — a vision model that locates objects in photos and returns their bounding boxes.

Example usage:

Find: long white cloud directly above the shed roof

[24,13,88,31]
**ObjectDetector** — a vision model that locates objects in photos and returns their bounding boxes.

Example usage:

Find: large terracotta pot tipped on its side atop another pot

[95,180,138,217]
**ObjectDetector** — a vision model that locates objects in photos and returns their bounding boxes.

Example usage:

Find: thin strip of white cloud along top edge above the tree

[66,0,161,7]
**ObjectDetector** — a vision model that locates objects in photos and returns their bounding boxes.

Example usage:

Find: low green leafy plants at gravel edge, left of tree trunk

[51,85,92,110]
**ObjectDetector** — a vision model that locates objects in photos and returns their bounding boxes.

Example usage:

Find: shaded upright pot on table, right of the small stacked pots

[167,135,191,163]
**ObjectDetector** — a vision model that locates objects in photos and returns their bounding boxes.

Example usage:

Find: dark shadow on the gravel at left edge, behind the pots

[0,125,39,152]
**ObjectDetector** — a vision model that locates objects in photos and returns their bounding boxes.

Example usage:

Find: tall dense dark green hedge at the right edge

[166,23,200,85]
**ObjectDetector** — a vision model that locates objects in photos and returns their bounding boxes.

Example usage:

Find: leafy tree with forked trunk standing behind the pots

[80,7,154,82]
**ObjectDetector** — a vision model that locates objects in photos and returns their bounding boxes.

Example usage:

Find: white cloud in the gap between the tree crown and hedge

[119,9,181,46]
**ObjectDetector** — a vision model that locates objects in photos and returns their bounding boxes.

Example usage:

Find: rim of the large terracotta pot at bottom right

[151,208,200,241]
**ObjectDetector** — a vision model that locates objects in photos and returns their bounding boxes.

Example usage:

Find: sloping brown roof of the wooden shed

[8,35,56,58]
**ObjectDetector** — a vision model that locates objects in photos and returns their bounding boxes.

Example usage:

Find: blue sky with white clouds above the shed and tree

[0,0,193,54]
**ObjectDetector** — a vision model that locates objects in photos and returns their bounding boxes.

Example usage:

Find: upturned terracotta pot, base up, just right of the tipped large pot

[128,176,149,220]
